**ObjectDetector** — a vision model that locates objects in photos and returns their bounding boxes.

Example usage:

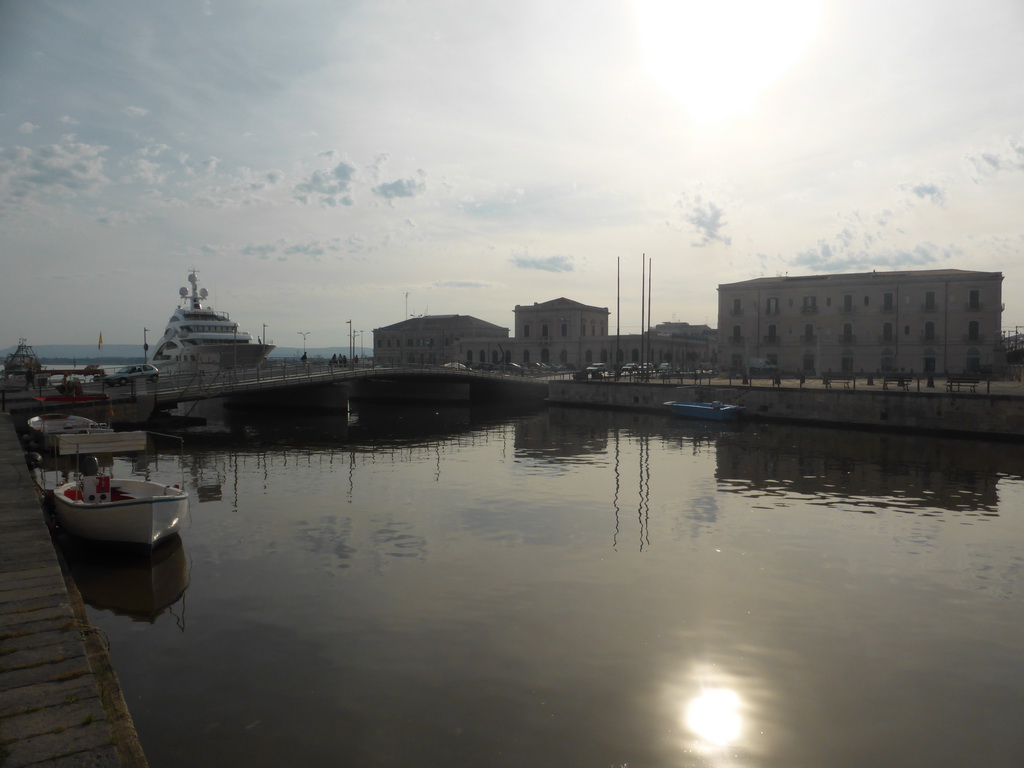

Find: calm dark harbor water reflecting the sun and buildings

[72,406,1024,768]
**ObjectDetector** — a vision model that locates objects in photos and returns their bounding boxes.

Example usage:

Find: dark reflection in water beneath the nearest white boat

[60,534,188,629]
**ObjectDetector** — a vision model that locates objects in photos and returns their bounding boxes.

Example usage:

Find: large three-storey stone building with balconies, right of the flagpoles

[718,269,1005,374]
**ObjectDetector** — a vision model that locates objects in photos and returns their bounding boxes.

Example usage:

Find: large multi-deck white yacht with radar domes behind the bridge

[152,269,274,373]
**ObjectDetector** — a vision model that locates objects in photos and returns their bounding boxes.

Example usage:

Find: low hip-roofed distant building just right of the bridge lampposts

[374,314,509,366]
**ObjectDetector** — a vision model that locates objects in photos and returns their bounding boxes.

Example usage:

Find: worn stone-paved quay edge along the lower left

[0,415,146,768]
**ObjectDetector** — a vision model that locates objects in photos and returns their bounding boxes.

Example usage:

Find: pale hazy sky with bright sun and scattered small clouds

[0,0,1024,347]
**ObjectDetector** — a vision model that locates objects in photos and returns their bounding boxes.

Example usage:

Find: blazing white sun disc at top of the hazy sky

[634,0,821,124]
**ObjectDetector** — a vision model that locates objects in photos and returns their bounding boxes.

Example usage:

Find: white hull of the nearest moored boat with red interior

[53,478,188,547]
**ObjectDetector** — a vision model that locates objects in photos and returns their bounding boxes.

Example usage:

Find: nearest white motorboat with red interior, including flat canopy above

[53,432,188,547]
